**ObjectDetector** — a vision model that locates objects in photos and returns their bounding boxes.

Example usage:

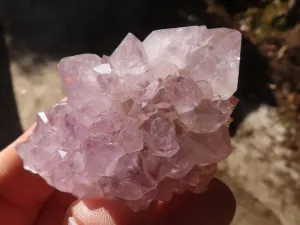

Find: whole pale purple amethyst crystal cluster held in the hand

[17,26,241,211]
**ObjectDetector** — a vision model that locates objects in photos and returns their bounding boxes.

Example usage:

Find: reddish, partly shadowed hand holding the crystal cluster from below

[0,127,236,225]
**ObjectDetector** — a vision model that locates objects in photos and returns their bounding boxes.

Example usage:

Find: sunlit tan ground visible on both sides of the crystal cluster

[11,59,300,225]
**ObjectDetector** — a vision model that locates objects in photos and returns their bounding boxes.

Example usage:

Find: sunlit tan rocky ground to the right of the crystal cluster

[219,105,300,225]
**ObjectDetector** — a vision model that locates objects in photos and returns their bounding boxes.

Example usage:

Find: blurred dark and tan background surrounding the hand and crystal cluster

[0,0,300,225]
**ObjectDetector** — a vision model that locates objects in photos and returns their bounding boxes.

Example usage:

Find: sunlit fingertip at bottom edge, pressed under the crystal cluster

[64,199,130,225]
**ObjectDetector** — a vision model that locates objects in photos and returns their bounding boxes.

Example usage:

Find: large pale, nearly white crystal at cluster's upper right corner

[143,26,241,99]
